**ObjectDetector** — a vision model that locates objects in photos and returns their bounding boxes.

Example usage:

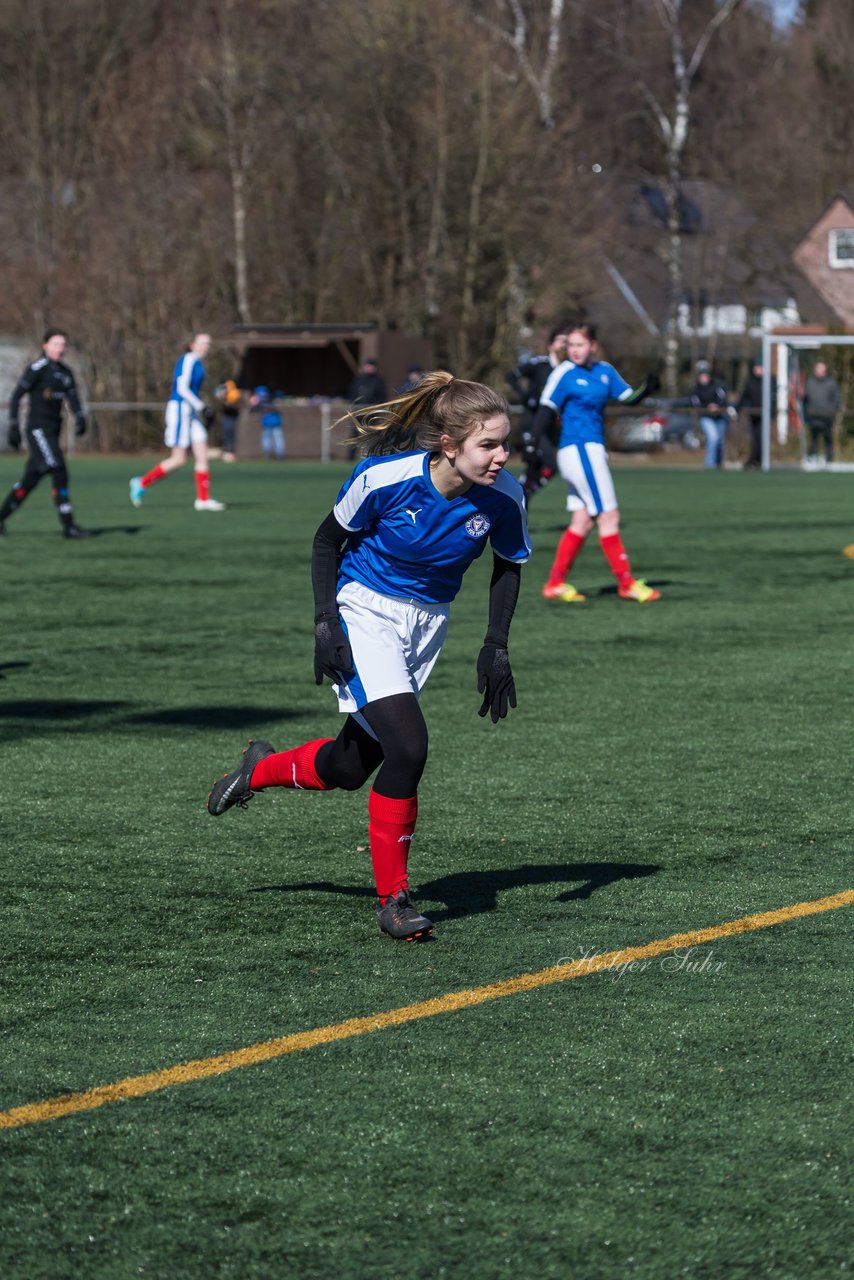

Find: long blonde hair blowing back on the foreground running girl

[335,369,510,457]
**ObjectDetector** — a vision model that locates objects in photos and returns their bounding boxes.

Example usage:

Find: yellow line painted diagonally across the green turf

[0,890,854,1129]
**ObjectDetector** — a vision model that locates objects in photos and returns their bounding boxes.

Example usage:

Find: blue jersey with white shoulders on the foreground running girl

[333,451,531,604]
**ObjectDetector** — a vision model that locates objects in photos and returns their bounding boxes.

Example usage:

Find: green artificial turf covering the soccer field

[0,457,854,1280]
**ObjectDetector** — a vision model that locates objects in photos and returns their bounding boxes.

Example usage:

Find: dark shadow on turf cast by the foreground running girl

[250,863,661,924]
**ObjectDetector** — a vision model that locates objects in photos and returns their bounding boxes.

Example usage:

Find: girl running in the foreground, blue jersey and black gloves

[207,372,530,938]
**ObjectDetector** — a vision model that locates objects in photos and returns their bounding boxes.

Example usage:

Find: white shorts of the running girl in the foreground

[333,582,451,736]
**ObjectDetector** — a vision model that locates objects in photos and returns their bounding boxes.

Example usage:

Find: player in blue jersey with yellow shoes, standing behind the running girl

[533,324,661,604]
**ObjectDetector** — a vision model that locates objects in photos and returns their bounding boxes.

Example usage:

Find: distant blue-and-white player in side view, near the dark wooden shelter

[131,333,225,511]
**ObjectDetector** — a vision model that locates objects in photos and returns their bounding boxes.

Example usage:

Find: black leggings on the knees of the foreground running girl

[315,694,428,800]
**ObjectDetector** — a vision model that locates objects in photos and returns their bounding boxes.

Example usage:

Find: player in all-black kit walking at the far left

[0,329,91,538]
